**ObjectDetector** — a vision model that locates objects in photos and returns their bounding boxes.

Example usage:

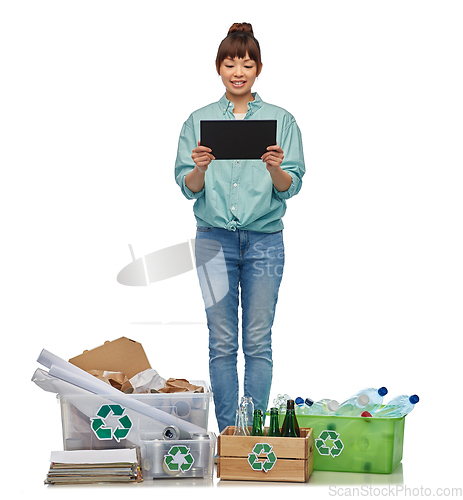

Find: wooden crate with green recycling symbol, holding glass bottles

[217,426,314,483]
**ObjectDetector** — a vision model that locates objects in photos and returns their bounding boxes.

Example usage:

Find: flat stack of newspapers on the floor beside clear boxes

[45,449,142,484]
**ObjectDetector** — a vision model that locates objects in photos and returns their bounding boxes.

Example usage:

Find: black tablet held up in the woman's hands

[200,120,277,160]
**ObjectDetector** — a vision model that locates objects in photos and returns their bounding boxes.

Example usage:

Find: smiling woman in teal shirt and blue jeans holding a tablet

[175,23,305,431]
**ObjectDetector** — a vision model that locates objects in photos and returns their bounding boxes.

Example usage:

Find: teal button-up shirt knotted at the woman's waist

[175,93,305,233]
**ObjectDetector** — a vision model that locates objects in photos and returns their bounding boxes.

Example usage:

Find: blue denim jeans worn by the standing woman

[195,227,284,432]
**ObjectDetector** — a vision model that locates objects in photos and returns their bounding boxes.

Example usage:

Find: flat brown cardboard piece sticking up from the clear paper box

[69,337,151,379]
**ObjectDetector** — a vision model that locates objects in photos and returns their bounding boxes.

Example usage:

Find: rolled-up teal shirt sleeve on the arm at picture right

[273,119,305,200]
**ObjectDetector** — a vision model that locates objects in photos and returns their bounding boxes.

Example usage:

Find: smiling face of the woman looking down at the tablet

[220,54,258,97]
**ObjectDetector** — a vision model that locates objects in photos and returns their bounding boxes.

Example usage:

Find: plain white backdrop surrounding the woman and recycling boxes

[0,0,463,498]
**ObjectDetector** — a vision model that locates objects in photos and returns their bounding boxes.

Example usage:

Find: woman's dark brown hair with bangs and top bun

[215,23,262,74]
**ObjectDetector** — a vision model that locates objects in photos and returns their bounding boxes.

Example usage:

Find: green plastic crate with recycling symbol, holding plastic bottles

[290,415,405,474]
